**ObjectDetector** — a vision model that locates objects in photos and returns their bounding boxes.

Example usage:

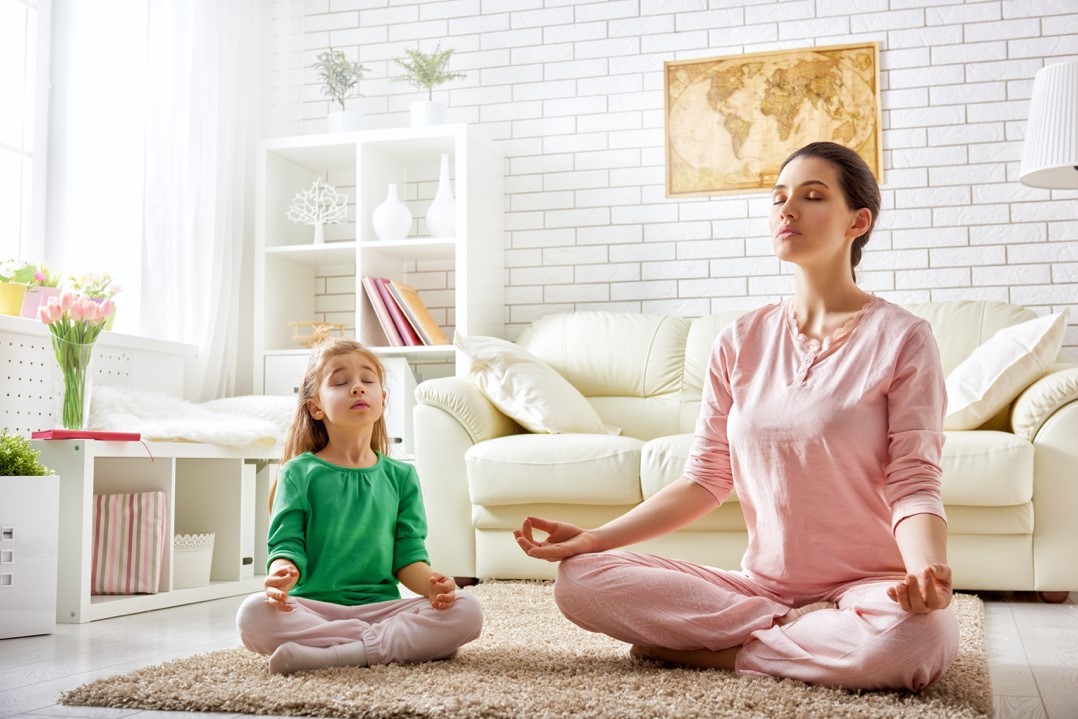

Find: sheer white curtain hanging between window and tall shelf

[140,0,262,400]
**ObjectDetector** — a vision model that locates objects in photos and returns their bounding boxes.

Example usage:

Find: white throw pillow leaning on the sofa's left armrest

[453,332,621,434]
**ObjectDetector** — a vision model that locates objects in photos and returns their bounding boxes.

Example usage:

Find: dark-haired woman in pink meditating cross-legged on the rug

[515,142,958,690]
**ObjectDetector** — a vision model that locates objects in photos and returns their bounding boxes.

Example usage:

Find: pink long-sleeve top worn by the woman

[686,298,946,597]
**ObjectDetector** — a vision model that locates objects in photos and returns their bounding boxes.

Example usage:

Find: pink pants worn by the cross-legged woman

[554,552,958,691]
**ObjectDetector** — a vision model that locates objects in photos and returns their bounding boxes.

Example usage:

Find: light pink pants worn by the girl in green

[236,592,483,664]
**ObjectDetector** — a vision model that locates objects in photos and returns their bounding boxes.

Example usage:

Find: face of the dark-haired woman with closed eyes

[769,157,872,272]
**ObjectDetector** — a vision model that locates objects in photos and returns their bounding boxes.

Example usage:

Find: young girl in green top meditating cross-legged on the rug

[242,340,483,674]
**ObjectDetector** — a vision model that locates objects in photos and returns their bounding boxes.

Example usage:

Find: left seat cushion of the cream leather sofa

[465,434,644,504]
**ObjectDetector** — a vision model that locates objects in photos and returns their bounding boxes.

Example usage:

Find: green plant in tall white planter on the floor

[0,428,60,639]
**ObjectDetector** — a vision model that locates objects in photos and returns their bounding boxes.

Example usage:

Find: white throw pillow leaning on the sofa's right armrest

[943,312,1067,429]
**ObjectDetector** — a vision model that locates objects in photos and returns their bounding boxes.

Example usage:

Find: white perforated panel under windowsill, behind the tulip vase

[0,334,132,435]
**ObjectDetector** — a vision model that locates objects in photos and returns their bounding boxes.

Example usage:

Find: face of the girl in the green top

[307,351,386,427]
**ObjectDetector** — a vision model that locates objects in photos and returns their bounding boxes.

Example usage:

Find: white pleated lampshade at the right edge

[1019,61,1078,190]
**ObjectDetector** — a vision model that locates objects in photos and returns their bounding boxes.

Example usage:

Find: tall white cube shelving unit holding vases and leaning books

[253,124,505,393]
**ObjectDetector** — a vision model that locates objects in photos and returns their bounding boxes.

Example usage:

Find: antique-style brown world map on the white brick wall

[663,42,883,197]
